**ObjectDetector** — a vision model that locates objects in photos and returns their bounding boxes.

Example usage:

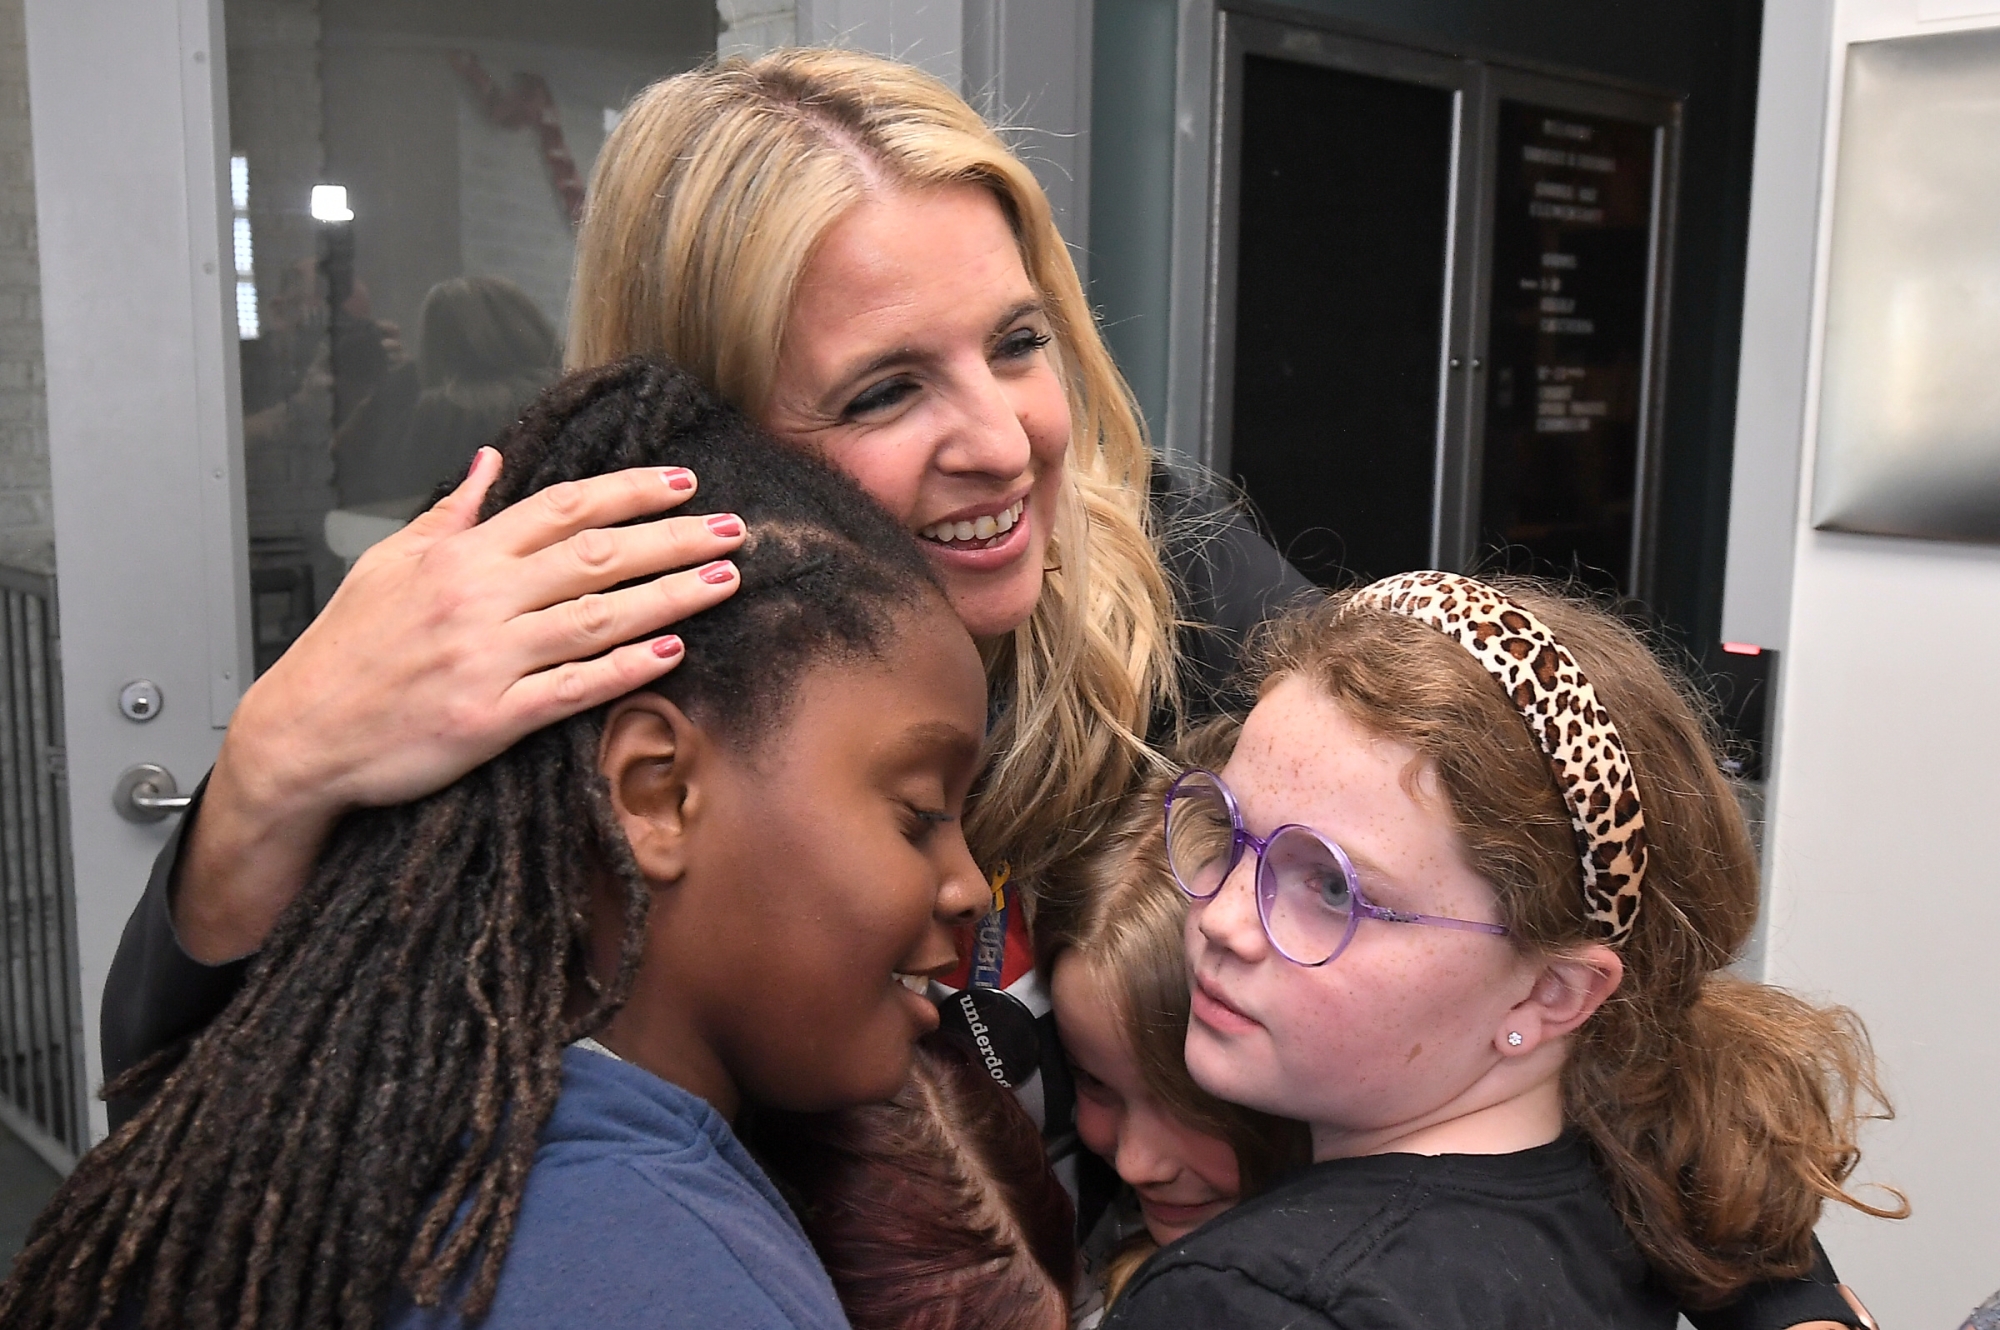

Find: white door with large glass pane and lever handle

[19,0,716,1134]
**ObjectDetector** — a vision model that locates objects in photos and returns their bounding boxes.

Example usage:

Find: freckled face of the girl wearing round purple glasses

[1186,676,1540,1158]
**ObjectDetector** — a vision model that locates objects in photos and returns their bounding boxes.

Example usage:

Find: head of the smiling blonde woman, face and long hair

[568,50,1184,882]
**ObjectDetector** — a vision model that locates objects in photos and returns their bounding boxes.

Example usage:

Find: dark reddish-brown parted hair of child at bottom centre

[750,1034,1076,1330]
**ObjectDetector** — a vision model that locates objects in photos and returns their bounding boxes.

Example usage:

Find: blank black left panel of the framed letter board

[1230,54,1458,582]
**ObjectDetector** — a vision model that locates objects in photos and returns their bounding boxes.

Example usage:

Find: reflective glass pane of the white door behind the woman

[224,0,716,672]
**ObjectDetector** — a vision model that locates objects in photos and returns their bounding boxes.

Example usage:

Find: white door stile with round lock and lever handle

[26,0,250,1136]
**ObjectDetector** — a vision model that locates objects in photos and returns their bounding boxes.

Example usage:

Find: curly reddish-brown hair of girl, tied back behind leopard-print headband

[1260,578,1908,1308]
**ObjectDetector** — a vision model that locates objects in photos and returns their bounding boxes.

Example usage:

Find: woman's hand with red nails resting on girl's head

[174,448,742,964]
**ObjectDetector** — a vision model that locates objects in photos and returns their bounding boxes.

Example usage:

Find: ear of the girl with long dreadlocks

[598,692,706,884]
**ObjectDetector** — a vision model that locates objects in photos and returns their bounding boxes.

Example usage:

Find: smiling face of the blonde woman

[762,184,1070,638]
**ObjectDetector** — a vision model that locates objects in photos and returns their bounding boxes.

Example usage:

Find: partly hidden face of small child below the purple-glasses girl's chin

[1050,952,1242,1246]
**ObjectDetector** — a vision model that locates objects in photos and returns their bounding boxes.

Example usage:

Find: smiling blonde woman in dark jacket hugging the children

[104,50,1304,1096]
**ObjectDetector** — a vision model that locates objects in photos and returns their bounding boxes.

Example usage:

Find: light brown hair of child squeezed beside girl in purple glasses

[1036,718,1312,1302]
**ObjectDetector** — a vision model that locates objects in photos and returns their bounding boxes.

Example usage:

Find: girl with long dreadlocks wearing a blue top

[0,352,988,1330]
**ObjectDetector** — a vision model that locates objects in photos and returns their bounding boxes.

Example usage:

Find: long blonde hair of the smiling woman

[568,48,1176,886]
